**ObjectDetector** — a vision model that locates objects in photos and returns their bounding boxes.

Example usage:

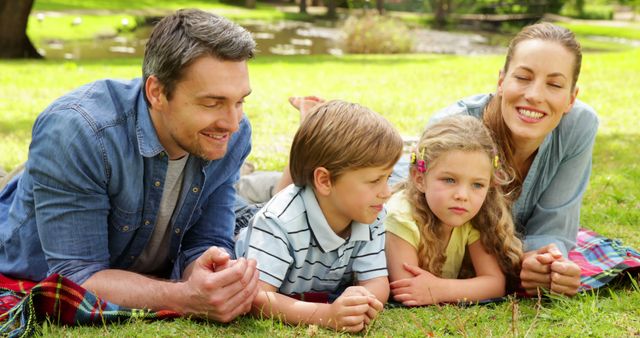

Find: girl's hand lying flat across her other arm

[389,263,442,306]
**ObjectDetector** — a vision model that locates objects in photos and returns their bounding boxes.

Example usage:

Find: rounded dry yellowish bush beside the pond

[342,13,414,54]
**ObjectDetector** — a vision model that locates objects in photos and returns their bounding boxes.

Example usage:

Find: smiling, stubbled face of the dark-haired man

[151,56,251,160]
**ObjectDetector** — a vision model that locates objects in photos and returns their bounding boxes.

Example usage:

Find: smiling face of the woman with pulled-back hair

[498,40,578,147]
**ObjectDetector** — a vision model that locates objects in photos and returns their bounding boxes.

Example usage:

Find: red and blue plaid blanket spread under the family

[0,229,640,337]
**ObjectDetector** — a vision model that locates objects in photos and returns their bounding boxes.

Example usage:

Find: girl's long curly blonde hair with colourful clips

[404,115,522,280]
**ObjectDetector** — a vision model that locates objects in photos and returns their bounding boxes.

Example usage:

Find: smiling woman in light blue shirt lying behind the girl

[242,23,598,295]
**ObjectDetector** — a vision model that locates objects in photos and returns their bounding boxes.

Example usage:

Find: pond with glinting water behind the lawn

[37,21,506,60]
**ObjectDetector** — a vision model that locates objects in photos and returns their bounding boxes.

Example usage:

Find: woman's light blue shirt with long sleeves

[431,94,598,257]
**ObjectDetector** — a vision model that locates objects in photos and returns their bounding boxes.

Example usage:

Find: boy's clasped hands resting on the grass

[327,286,377,332]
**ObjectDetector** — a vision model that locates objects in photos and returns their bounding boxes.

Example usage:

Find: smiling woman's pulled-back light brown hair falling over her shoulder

[483,22,582,198]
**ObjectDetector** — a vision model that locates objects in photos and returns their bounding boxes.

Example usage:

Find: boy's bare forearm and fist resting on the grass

[251,281,370,332]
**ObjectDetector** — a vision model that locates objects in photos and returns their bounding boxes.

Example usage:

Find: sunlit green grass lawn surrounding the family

[0,49,640,337]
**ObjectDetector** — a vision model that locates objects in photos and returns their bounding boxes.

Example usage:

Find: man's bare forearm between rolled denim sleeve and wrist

[82,269,184,313]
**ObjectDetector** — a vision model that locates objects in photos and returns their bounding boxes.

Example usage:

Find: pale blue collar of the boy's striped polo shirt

[302,187,371,252]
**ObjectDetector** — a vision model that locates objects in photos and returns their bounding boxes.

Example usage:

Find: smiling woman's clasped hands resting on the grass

[520,243,580,296]
